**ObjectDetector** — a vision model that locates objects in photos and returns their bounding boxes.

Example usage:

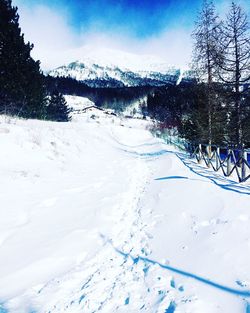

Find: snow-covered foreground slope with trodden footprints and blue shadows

[0,105,250,313]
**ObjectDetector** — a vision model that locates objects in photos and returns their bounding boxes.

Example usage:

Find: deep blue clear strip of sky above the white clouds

[15,0,201,38]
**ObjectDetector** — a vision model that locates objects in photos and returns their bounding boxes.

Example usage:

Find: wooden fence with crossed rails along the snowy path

[192,144,250,183]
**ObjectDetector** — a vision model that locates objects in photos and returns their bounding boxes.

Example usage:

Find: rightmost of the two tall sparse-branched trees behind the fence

[220,2,250,145]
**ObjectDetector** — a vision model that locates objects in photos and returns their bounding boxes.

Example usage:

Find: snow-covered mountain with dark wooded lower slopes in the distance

[49,49,193,87]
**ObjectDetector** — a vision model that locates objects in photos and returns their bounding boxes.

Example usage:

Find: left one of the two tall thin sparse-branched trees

[192,0,224,144]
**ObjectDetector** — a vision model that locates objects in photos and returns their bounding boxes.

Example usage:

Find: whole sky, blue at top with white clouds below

[13,0,250,68]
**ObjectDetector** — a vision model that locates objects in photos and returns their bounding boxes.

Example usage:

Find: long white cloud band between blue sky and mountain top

[15,0,191,70]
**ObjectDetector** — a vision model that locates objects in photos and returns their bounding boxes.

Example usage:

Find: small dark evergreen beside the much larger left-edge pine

[46,91,72,122]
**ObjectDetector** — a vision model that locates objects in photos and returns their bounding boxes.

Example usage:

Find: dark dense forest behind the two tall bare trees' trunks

[147,83,250,147]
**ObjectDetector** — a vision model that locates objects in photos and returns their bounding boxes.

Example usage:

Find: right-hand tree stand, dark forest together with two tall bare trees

[148,0,250,147]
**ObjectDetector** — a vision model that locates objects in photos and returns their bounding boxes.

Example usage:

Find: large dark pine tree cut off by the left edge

[0,0,45,118]
